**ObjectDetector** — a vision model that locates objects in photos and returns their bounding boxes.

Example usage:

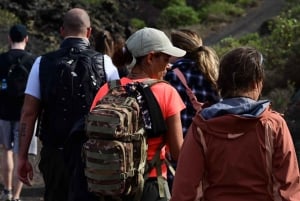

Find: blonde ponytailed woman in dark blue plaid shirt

[164,29,220,189]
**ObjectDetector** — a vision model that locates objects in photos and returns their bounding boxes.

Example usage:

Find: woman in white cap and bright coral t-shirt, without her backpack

[91,27,185,201]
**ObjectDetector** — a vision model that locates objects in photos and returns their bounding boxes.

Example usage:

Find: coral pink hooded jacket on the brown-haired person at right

[171,108,300,201]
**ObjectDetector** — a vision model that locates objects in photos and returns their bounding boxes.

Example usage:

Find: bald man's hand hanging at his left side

[18,158,33,186]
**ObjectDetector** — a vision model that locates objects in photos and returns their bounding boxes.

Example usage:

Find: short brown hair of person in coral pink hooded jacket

[218,47,264,98]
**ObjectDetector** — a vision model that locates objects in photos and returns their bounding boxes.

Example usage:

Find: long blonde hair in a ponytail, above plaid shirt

[171,29,219,88]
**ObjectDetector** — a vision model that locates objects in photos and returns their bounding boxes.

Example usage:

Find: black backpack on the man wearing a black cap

[2,54,32,97]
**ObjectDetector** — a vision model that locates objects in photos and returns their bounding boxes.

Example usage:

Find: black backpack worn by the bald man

[39,48,106,146]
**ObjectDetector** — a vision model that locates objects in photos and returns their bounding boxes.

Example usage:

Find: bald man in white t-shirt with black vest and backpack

[18,8,119,201]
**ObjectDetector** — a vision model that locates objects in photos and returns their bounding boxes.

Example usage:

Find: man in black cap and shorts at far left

[0,24,36,201]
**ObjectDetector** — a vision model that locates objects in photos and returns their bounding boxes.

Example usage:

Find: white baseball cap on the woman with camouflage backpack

[126,27,186,58]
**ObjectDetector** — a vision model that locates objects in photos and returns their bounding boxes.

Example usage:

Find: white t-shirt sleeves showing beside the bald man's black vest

[25,55,119,99]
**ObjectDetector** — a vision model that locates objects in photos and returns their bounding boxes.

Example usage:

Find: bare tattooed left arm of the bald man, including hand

[18,94,40,186]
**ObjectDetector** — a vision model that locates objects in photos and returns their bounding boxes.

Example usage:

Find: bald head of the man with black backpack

[63,8,91,36]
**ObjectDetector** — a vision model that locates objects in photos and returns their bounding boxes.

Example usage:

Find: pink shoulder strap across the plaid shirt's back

[173,68,203,112]
